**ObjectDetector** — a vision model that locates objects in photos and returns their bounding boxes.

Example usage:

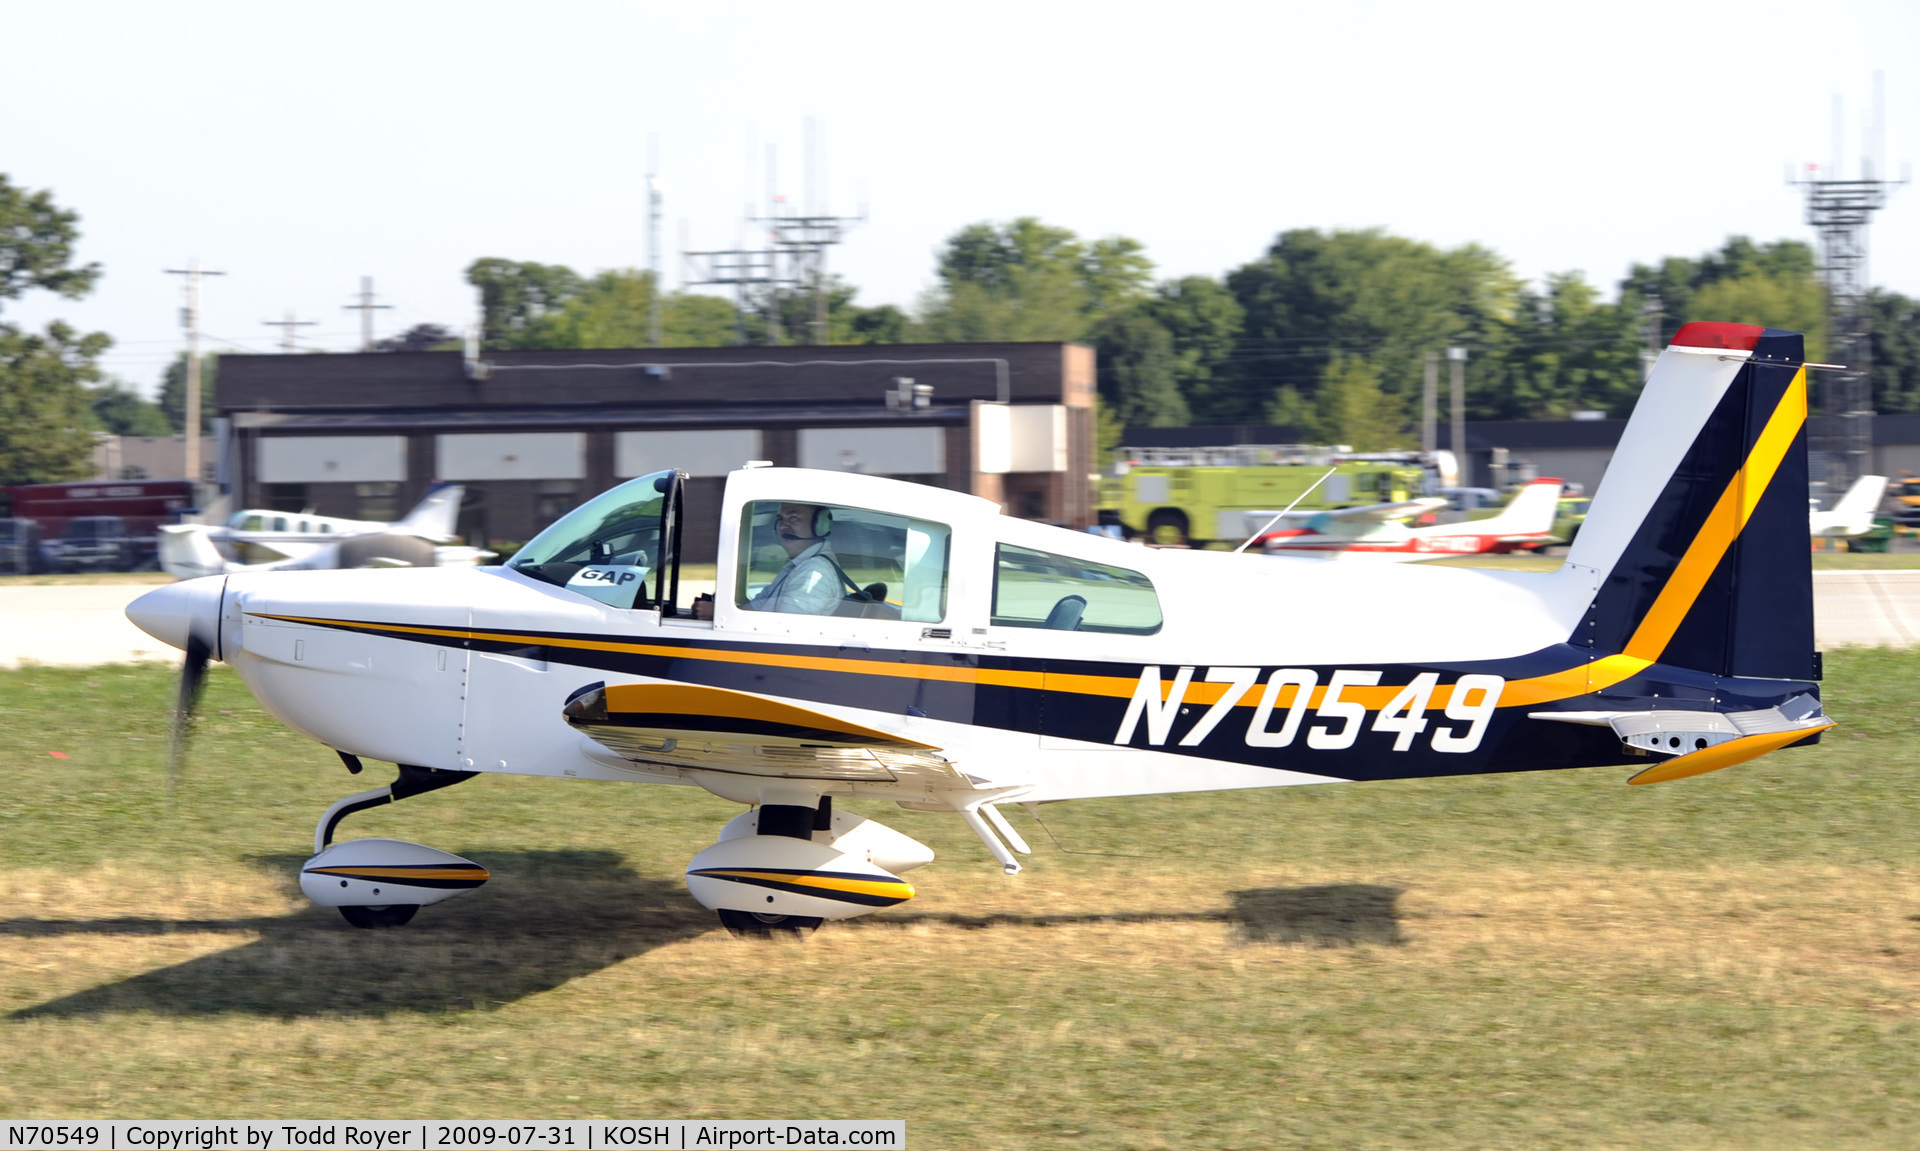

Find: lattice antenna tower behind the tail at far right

[1789,71,1907,503]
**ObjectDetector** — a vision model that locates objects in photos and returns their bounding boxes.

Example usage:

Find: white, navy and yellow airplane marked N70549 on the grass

[127,323,1832,934]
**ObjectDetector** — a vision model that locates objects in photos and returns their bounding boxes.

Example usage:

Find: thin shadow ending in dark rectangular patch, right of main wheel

[854,884,1405,947]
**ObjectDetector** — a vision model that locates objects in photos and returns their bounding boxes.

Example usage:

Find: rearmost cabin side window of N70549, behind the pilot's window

[993,544,1160,636]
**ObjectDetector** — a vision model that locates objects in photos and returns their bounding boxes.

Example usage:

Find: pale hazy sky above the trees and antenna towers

[0,0,1920,388]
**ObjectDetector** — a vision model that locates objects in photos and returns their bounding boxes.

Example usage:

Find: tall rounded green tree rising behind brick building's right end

[922,217,1152,344]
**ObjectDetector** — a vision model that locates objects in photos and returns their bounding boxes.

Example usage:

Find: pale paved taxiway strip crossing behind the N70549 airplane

[0,571,1920,667]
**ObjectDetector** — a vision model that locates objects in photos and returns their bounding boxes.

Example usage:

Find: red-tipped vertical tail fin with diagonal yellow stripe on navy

[1567,323,1814,678]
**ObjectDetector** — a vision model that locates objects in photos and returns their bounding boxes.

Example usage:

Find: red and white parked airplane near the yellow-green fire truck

[1246,478,1565,563]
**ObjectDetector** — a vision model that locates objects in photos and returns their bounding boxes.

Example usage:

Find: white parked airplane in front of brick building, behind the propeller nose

[159,484,482,580]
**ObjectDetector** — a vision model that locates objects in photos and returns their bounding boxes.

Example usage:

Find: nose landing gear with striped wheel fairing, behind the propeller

[300,755,488,928]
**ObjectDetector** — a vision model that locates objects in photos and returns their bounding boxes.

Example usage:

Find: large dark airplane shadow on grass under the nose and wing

[0,851,718,1018]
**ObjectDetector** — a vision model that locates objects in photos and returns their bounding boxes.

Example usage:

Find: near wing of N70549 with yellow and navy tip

[564,684,975,790]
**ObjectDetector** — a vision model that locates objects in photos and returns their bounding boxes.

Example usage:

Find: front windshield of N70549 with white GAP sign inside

[507,471,676,607]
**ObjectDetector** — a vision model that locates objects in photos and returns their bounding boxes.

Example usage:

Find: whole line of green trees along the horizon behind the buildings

[0,175,1920,482]
